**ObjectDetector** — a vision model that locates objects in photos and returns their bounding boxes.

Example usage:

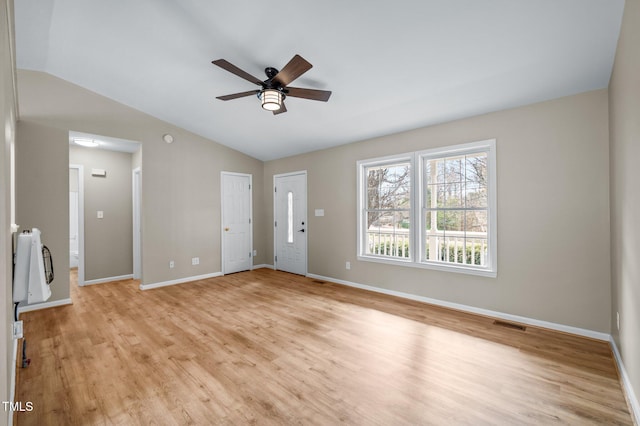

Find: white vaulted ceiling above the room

[15,0,624,160]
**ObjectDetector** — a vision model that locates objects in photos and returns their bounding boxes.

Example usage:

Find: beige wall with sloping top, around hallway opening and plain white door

[17,70,265,284]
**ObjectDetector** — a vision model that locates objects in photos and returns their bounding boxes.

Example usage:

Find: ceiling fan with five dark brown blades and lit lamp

[211,55,331,115]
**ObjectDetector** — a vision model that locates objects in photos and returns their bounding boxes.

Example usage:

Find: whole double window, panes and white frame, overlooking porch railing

[358,140,497,276]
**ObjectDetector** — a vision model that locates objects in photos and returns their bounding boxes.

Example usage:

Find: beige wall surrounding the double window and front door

[264,90,610,332]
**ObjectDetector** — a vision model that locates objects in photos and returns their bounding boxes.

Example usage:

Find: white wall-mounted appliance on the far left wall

[13,228,53,304]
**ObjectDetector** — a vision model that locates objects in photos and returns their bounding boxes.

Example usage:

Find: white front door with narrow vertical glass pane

[273,171,308,275]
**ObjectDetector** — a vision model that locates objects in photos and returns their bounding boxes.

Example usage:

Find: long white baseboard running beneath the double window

[307,274,610,342]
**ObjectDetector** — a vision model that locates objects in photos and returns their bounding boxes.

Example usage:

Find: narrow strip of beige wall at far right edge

[609,0,640,414]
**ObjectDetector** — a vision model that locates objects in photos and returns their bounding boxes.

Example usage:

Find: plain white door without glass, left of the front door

[221,172,253,274]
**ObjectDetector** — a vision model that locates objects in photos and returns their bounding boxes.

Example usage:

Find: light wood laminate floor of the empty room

[15,269,632,426]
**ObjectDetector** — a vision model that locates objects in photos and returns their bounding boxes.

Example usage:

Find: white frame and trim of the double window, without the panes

[356,139,498,277]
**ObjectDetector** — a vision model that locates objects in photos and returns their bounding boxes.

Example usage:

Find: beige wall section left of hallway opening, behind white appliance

[16,120,69,301]
